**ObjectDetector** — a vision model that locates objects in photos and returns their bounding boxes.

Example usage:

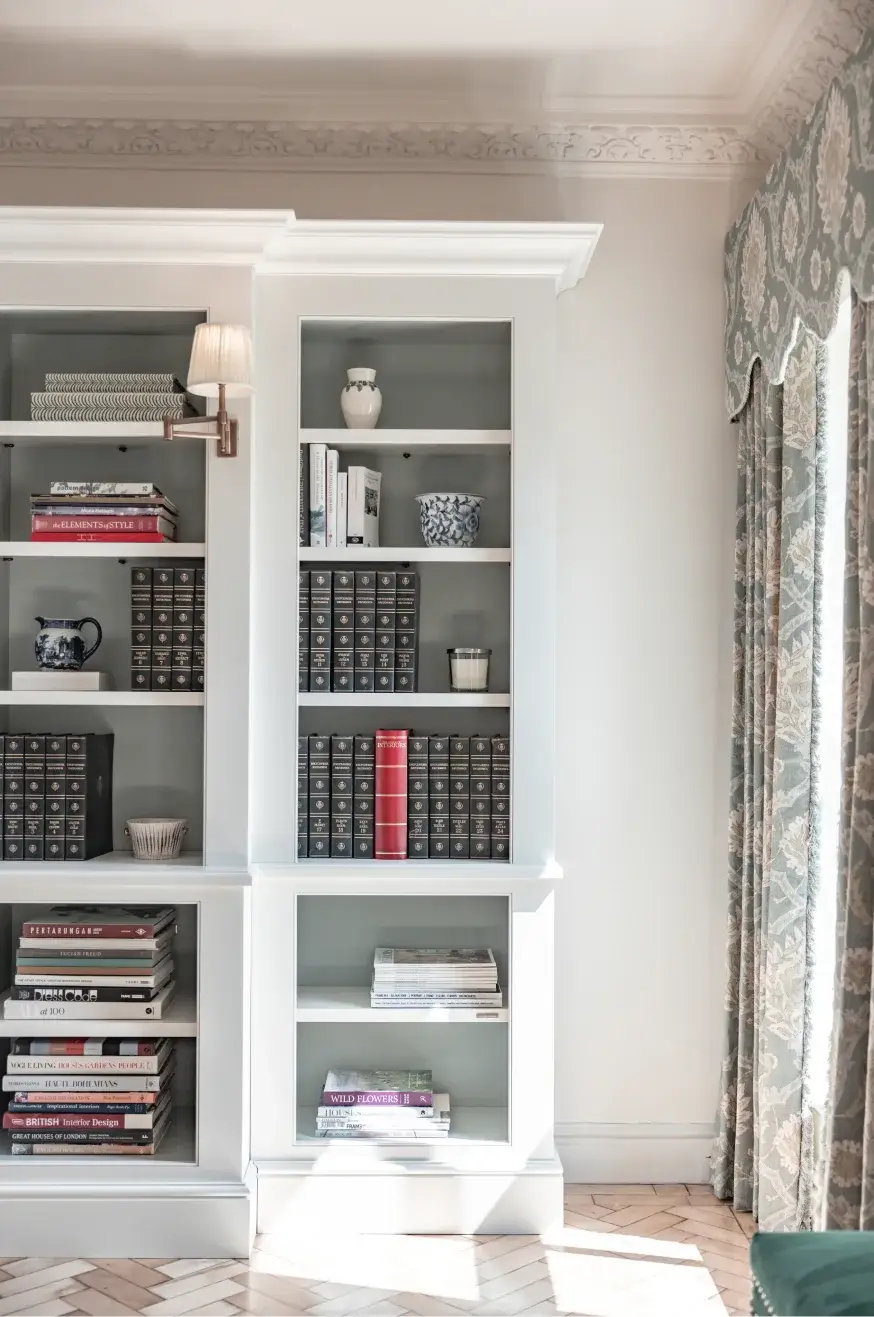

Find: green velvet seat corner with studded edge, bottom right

[750,1230,874,1317]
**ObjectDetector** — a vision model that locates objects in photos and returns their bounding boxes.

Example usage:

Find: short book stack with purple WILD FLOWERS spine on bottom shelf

[316,1069,449,1139]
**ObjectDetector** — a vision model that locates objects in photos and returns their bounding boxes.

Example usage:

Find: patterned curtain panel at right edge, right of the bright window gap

[825,294,874,1230]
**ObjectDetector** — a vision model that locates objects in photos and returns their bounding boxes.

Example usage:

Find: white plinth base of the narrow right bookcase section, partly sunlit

[258,1158,563,1238]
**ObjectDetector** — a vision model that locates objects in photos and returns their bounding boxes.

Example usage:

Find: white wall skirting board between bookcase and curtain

[555,1122,715,1184]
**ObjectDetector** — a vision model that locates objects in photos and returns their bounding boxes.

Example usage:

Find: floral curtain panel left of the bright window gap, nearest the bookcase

[712,331,826,1230]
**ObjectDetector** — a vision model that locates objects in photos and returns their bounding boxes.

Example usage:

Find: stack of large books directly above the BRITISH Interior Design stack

[4,906,176,1021]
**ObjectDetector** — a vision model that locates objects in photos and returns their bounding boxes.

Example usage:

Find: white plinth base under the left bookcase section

[0,1185,255,1258]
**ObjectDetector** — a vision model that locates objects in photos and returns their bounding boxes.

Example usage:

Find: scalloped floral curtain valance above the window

[725,30,874,416]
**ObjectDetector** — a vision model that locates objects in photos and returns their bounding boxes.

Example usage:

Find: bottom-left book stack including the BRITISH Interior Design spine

[3,1038,175,1156]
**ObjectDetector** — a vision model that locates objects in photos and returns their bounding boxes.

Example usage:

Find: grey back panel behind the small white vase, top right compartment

[300,319,511,434]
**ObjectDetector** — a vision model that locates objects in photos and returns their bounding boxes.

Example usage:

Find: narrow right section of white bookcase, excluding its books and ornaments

[250,223,598,1233]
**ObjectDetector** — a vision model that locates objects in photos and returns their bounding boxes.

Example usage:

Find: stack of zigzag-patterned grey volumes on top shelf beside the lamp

[30,371,187,421]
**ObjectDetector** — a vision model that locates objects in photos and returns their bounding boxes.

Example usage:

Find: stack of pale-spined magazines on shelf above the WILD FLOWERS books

[370,947,503,1010]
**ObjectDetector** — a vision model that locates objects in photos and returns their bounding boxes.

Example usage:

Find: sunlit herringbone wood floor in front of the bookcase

[0,1184,753,1317]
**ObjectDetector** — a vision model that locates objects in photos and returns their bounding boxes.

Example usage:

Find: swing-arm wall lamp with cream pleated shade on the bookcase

[165,324,253,457]
